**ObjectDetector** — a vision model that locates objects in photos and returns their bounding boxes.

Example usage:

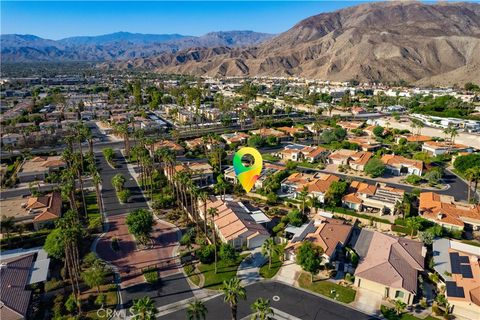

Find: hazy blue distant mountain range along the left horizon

[0,31,272,62]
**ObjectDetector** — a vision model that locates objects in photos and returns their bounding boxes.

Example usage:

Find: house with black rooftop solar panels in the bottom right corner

[432,238,480,319]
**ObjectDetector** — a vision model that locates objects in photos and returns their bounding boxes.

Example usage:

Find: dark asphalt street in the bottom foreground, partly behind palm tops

[160,281,376,320]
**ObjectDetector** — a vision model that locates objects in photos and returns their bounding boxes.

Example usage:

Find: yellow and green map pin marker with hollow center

[233,147,263,192]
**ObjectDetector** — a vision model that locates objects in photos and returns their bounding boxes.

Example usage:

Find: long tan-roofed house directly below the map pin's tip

[198,196,270,249]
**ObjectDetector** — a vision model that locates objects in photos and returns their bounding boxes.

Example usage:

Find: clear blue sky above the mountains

[1,0,372,40]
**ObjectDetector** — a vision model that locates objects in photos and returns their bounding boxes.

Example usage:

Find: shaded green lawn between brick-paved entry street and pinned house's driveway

[198,255,247,290]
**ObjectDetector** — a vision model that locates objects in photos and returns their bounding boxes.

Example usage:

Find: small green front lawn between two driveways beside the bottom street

[298,273,356,303]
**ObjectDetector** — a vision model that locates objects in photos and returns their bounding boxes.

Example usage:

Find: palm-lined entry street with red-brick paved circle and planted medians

[96,151,193,306]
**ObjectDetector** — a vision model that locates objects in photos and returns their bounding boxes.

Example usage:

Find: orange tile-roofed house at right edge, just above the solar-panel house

[418,192,480,230]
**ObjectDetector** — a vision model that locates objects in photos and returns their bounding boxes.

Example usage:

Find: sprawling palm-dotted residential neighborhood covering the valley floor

[0,0,480,320]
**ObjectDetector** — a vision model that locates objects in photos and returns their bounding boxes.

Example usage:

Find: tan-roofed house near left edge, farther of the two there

[17,156,66,182]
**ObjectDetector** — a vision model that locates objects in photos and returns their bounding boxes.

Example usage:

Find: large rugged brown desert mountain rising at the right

[109,2,480,85]
